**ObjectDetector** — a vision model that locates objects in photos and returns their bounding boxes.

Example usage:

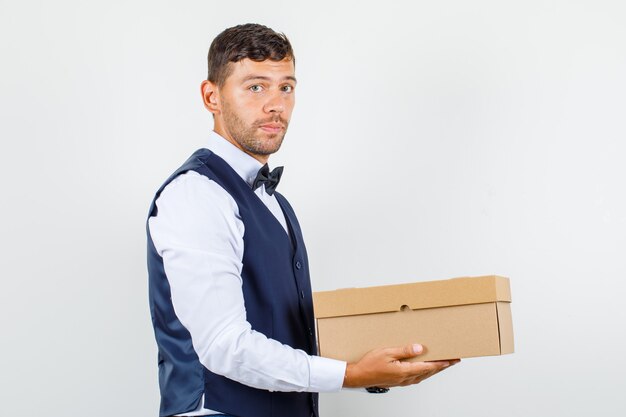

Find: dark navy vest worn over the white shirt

[148,149,318,417]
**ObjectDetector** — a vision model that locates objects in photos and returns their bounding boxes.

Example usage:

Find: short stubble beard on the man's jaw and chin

[222,102,289,155]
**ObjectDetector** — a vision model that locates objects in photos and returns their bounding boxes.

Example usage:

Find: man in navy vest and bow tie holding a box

[148,24,456,417]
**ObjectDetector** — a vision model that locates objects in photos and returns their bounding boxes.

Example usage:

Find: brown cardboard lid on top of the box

[313,275,511,319]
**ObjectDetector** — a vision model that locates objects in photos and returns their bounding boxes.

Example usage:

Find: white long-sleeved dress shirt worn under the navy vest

[148,132,346,416]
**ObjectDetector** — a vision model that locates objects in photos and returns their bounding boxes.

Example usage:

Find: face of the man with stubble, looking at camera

[206,59,296,162]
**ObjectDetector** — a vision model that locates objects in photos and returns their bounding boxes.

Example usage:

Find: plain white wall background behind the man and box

[0,0,626,417]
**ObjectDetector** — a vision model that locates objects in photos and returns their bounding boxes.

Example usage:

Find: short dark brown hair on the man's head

[207,23,296,87]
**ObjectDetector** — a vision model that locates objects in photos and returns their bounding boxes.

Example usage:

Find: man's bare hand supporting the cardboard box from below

[343,344,461,388]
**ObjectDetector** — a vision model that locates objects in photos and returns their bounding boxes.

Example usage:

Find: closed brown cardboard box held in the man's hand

[313,275,513,362]
